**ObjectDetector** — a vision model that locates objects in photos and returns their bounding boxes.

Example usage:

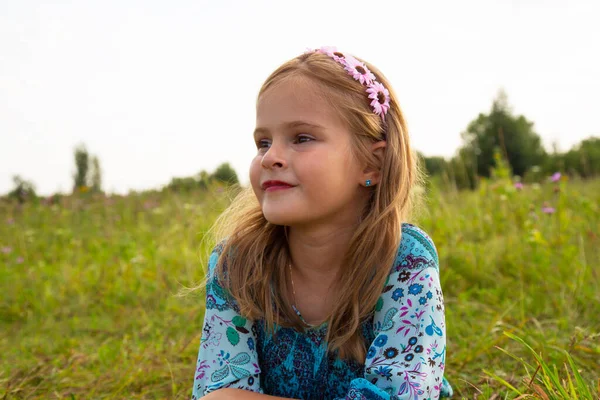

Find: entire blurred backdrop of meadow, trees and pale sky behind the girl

[0,0,600,399]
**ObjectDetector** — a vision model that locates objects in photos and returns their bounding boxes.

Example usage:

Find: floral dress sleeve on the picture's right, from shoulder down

[338,226,452,400]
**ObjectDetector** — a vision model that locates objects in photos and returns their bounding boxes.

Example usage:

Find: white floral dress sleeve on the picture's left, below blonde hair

[192,245,262,400]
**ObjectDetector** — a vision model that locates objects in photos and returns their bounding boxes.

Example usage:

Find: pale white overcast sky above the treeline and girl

[0,0,600,195]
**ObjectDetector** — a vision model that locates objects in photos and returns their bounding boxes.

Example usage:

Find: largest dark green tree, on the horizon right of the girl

[461,91,546,177]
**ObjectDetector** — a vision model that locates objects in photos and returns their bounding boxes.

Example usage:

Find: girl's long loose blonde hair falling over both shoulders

[213,53,421,362]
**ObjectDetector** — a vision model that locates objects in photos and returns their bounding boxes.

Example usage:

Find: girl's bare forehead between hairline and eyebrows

[256,79,341,128]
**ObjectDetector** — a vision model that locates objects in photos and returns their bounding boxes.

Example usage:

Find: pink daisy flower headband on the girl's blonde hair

[308,46,390,121]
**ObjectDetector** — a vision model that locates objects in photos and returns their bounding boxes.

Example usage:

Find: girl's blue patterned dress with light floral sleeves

[192,224,452,400]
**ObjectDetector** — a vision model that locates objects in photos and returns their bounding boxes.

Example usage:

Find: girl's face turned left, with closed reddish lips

[250,78,368,226]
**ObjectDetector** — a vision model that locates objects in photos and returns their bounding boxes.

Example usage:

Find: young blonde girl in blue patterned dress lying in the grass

[193,48,452,399]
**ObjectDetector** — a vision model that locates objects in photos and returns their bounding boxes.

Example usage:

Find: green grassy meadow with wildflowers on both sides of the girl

[0,177,600,399]
